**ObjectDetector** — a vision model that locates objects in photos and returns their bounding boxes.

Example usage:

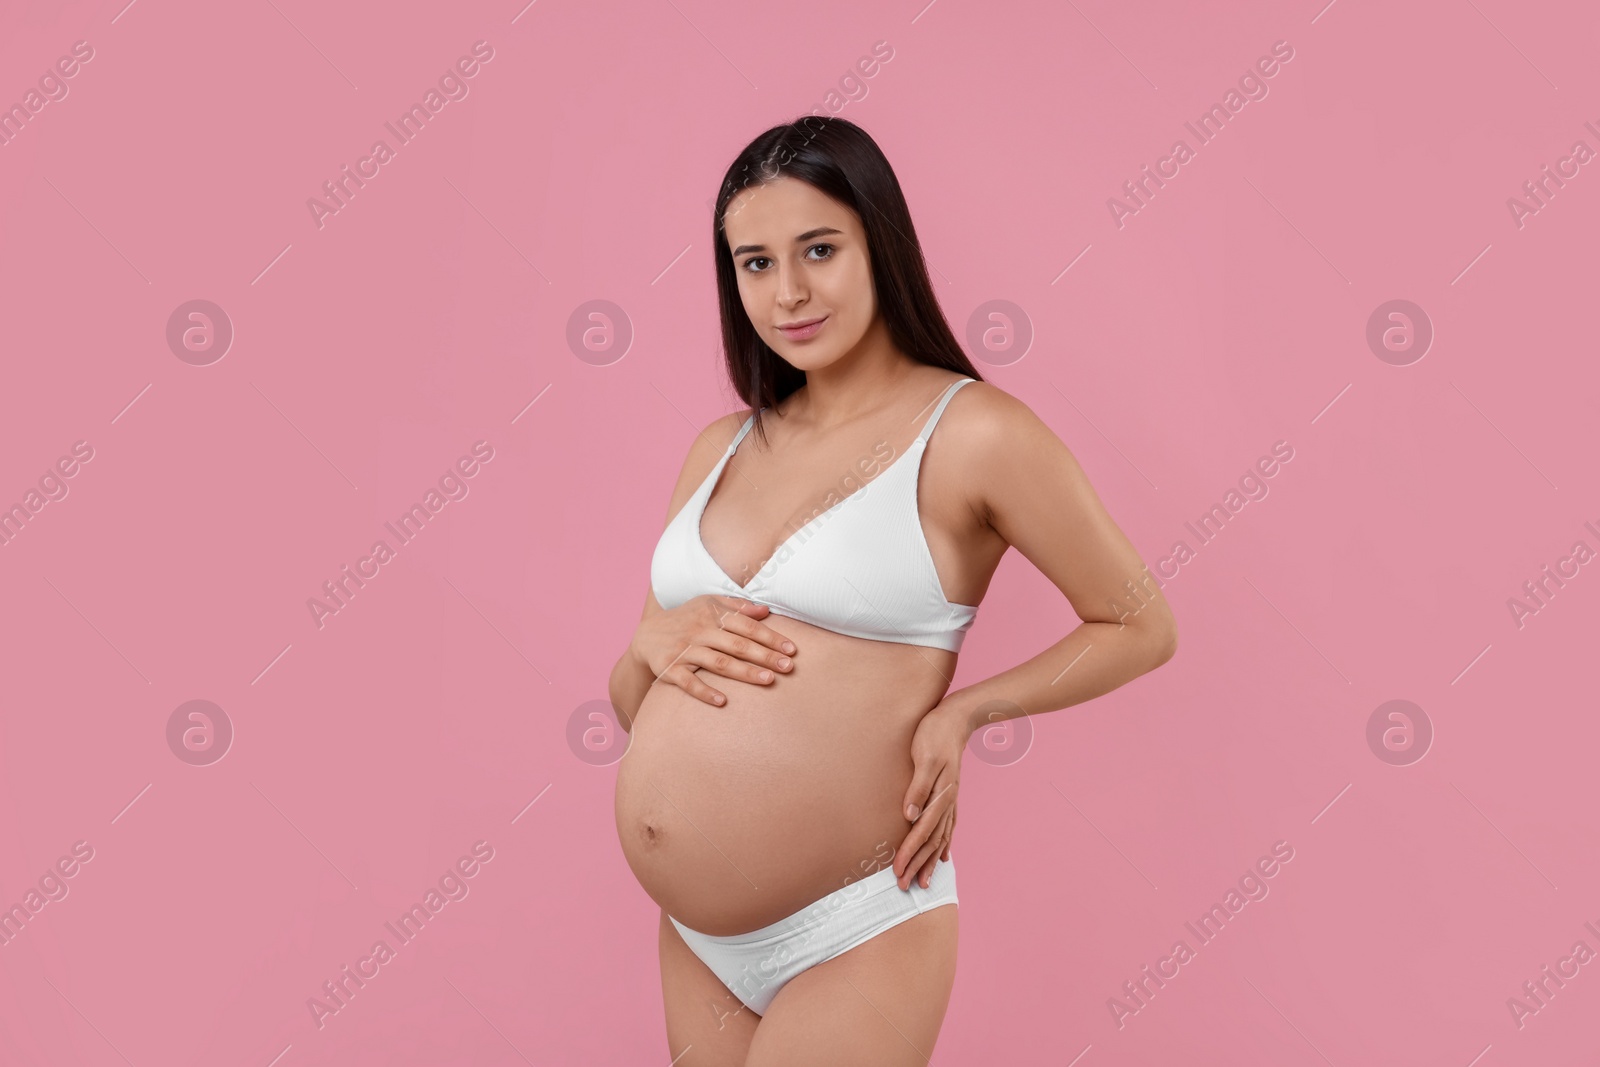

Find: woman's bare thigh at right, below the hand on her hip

[746,904,958,1067]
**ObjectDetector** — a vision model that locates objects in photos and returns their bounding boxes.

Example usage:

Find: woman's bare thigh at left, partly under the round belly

[661,912,762,1067]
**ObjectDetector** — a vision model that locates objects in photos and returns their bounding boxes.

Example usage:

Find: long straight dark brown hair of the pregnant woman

[712,115,982,440]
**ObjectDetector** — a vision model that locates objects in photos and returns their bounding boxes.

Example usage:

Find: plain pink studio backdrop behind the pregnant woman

[0,0,1600,1067]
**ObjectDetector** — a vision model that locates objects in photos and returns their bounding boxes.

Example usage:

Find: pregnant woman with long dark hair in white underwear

[611,118,1178,1067]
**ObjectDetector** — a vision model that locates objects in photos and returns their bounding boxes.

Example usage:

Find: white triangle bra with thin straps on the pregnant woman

[650,378,978,653]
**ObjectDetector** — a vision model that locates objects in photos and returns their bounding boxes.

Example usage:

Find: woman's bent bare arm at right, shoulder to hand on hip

[894,387,1178,889]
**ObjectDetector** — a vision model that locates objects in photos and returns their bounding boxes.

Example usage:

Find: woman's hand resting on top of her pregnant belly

[632,593,795,705]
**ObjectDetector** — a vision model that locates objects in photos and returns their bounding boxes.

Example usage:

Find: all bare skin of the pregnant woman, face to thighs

[611,178,1176,1067]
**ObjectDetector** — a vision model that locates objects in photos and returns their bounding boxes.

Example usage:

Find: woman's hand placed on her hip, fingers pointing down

[894,704,973,889]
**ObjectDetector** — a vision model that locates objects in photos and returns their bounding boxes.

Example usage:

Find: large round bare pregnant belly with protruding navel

[616,614,957,936]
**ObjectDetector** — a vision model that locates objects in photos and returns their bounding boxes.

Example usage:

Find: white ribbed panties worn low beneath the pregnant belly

[667,859,957,1014]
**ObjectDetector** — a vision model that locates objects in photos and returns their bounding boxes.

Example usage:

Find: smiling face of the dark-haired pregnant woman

[723,178,877,371]
